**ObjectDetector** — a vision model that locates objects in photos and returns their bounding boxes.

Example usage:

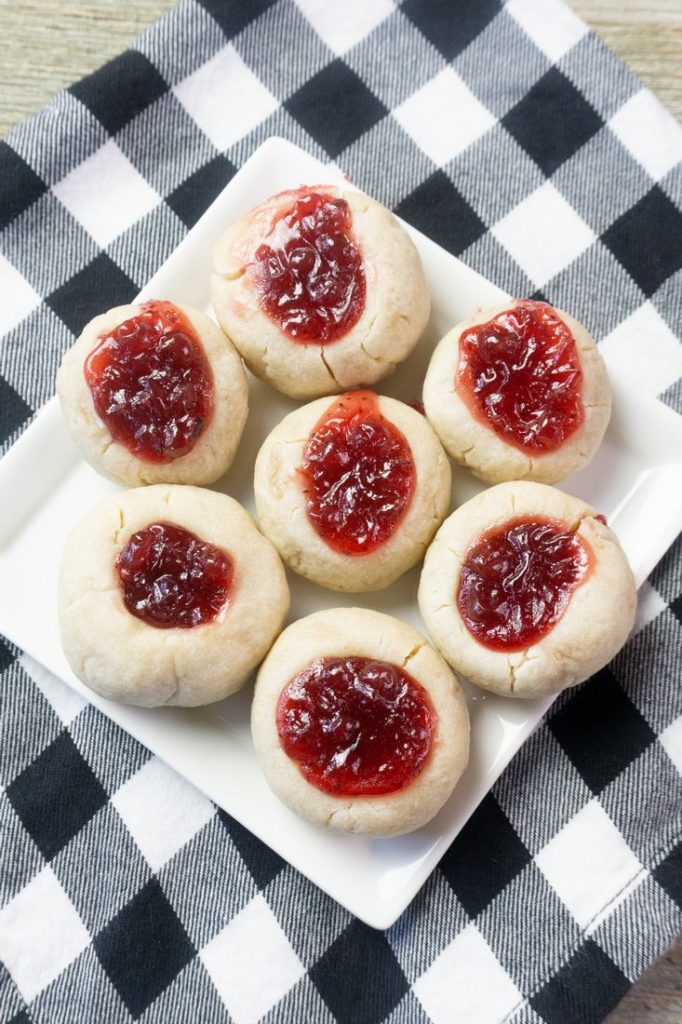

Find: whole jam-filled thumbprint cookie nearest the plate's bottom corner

[251,608,469,836]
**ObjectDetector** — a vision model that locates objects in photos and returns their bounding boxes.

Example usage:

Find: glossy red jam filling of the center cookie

[299,391,416,555]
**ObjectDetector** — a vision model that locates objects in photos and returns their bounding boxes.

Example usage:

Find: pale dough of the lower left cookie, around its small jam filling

[59,484,289,708]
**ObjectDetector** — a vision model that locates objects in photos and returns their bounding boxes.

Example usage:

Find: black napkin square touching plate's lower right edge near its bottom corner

[439,794,530,918]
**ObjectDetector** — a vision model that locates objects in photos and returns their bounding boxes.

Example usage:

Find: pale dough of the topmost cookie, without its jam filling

[211,184,431,399]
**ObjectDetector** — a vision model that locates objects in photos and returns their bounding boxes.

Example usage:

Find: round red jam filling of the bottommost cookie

[276,657,437,797]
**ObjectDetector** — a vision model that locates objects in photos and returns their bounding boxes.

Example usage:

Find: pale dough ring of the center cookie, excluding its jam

[254,395,451,593]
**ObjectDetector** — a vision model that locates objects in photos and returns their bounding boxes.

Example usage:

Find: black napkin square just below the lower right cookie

[549,669,655,794]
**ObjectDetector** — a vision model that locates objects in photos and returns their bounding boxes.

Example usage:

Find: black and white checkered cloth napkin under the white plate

[0,0,682,1024]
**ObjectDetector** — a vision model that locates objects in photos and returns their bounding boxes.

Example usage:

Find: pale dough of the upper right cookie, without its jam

[424,299,611,483]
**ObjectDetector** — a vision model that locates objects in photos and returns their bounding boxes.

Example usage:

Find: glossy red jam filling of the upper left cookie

[84,302,213,463]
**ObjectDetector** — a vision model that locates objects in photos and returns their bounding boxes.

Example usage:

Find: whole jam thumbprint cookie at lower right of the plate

[419,481,637,697]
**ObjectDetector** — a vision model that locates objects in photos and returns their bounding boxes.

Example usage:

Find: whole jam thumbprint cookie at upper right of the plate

[424,299,611,483]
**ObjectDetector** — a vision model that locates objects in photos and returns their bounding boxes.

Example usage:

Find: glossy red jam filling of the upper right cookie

[456,300,585,455]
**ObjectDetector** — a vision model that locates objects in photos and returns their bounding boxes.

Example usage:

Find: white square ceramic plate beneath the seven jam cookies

[0,139,682,928]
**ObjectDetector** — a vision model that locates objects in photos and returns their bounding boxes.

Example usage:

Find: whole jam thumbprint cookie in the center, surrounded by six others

[254,391,451,592]
